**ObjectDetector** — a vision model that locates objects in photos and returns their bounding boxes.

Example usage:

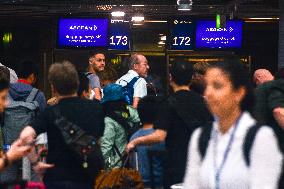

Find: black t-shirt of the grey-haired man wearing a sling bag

[32,97,104,182]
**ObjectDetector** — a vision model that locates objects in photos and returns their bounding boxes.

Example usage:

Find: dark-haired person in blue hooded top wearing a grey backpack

[0,61,46,181]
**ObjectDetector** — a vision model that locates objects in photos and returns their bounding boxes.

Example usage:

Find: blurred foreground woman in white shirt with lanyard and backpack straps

[184,60,282,189]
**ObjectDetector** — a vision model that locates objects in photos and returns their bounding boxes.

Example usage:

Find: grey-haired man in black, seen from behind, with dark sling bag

[20,61,104,189]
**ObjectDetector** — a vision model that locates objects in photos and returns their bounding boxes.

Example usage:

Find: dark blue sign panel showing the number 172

[170,20,195,50]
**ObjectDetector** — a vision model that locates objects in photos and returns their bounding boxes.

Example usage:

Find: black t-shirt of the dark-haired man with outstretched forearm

[154,90,213,184]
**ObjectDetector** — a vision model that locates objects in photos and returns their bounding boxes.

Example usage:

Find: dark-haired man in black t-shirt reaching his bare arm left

[126,62,212,189]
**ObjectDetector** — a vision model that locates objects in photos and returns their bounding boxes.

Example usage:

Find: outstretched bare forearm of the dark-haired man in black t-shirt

[125,129,167,152]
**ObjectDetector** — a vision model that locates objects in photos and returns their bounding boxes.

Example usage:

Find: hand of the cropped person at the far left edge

[6,139,32,162]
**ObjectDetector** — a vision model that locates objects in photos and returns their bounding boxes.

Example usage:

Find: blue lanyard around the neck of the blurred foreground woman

[213,114,242,189]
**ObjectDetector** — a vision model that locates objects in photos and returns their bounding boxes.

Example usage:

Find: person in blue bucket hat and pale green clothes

[101,84,140,169]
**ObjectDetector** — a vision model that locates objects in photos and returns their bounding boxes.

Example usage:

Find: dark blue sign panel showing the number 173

[109,22,130,50]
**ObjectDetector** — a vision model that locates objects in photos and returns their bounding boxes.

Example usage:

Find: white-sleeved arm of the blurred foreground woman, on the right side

[249,127,283,189]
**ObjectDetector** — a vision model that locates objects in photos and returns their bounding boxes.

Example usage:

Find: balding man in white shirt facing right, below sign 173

[116,54,150,108]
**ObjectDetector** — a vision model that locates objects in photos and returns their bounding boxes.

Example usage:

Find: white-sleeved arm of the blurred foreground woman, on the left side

[183,129,201,189]
